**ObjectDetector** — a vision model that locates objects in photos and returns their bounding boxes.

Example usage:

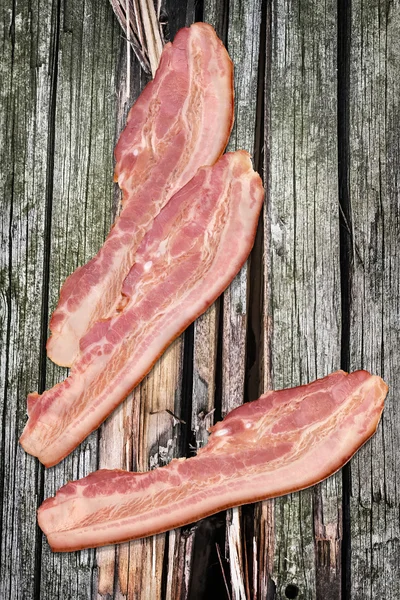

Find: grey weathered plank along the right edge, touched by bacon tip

[349,0,400,600]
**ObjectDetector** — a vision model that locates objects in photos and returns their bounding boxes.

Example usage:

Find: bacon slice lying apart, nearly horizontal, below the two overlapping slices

[38,371,388,552]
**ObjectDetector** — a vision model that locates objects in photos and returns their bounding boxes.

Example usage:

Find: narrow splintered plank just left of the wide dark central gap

[208,0,261,599]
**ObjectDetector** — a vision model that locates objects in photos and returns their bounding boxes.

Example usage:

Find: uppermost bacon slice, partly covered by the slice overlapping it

[47,23,233,366]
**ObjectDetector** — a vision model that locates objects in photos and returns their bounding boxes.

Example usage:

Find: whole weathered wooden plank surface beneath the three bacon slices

[0,0,400,600]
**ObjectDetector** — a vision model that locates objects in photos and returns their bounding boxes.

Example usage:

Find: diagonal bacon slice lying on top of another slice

[20,151,264,466]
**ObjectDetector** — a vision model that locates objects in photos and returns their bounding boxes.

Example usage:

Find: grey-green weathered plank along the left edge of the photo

[0,0,57,600]
